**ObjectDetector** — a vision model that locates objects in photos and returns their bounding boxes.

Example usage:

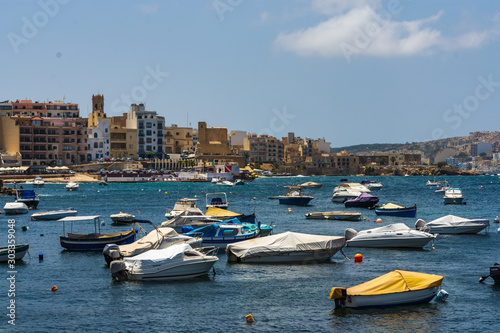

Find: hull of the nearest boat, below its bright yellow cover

[345,286,440,309]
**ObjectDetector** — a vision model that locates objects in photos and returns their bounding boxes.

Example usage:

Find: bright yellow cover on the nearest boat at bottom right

[347,270,443,296]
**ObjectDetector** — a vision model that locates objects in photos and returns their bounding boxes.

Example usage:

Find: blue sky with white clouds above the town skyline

[0,0,500,147]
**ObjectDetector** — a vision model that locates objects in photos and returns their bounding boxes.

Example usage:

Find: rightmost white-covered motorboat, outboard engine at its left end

[415,215,490,234]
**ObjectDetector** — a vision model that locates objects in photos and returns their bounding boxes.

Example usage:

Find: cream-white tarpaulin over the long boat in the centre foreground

[227,231,345,258]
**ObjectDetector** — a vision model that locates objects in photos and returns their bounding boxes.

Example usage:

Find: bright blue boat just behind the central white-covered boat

[186,219,262,248]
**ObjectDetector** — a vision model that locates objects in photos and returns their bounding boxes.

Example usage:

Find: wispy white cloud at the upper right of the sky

[274,0,497,62]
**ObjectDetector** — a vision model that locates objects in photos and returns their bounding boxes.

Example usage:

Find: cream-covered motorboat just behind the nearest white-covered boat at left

[102,220,203,265]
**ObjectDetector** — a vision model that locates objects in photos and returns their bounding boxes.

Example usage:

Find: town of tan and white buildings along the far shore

[0,94,500,175]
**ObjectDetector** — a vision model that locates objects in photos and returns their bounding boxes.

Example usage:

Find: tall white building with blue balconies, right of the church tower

[127,104,165,158]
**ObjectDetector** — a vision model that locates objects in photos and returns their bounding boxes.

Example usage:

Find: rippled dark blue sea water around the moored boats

[0,176,500,333]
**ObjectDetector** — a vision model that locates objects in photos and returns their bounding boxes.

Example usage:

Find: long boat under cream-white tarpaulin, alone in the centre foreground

[226,231,345,263]
